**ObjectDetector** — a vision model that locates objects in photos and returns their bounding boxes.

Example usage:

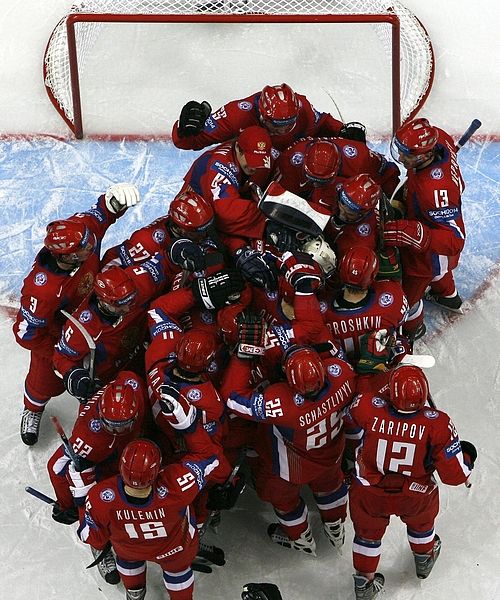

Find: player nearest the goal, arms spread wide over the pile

[172,83,365,150]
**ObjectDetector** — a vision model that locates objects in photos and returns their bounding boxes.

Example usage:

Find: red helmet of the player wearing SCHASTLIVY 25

[283,347,325,396]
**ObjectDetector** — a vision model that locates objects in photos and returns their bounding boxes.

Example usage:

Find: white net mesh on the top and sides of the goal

[45,0,433,134]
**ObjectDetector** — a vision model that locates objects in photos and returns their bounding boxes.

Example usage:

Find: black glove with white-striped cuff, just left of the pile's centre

[192,269,245,310]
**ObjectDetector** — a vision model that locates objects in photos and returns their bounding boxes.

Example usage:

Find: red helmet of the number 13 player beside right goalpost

[391,119,438,167]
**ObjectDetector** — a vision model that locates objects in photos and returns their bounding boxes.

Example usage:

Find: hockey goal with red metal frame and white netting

[44,0,434,138]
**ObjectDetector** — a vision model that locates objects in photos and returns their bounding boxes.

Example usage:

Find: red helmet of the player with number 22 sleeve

[97,380,139,435]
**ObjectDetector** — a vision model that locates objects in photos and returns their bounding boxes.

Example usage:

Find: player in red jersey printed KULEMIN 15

[78,398,225,600]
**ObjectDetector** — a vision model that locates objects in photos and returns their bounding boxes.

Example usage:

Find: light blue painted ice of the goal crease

[0,137,500,328]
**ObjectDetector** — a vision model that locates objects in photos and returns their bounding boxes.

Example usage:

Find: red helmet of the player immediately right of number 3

[94,266,137,315]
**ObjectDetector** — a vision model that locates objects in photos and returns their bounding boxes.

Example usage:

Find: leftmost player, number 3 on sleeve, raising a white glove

[13,183,140,446]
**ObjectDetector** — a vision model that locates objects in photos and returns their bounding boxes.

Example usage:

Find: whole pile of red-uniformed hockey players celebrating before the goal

[14,84,476,600]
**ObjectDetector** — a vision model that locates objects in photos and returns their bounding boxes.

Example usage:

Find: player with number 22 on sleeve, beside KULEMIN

[47,371,146,524]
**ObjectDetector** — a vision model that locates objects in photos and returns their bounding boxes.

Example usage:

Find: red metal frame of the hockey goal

[44,13,434,139]
